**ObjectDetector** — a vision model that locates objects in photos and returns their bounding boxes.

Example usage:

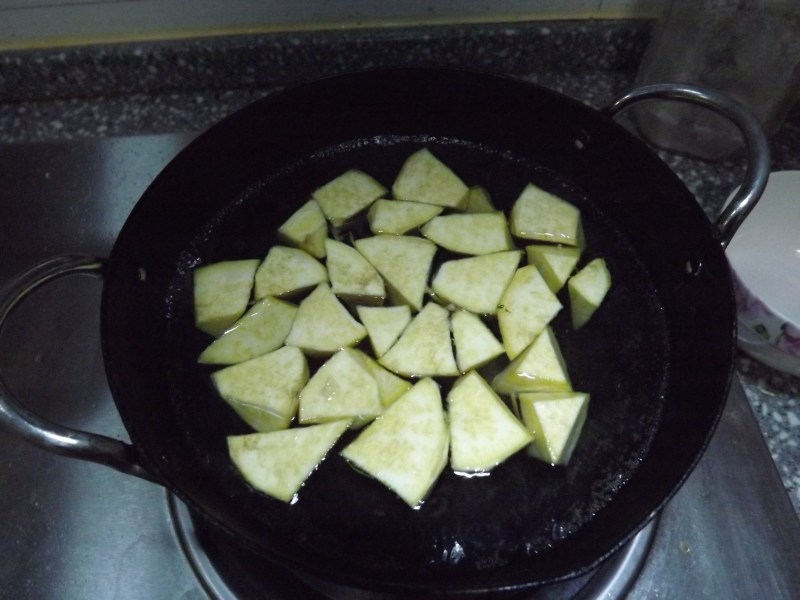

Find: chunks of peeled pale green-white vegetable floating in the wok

[194,149,610,507]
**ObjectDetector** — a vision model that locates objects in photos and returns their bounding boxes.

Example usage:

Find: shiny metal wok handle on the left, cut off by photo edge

[0,254,158,483]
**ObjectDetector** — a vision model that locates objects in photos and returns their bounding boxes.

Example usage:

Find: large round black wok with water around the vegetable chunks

[0,69,767,597]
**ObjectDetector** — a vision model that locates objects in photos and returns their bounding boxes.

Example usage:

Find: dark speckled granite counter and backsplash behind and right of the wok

[0,21,800,512]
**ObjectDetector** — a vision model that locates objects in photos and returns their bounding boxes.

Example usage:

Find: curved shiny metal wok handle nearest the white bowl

[602,83,770,248]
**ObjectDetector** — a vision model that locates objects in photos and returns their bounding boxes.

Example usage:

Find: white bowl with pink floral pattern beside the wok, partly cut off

[726,171,800,376]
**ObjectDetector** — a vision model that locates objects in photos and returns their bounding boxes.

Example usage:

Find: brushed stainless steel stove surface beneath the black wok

[0,134,800,600]
